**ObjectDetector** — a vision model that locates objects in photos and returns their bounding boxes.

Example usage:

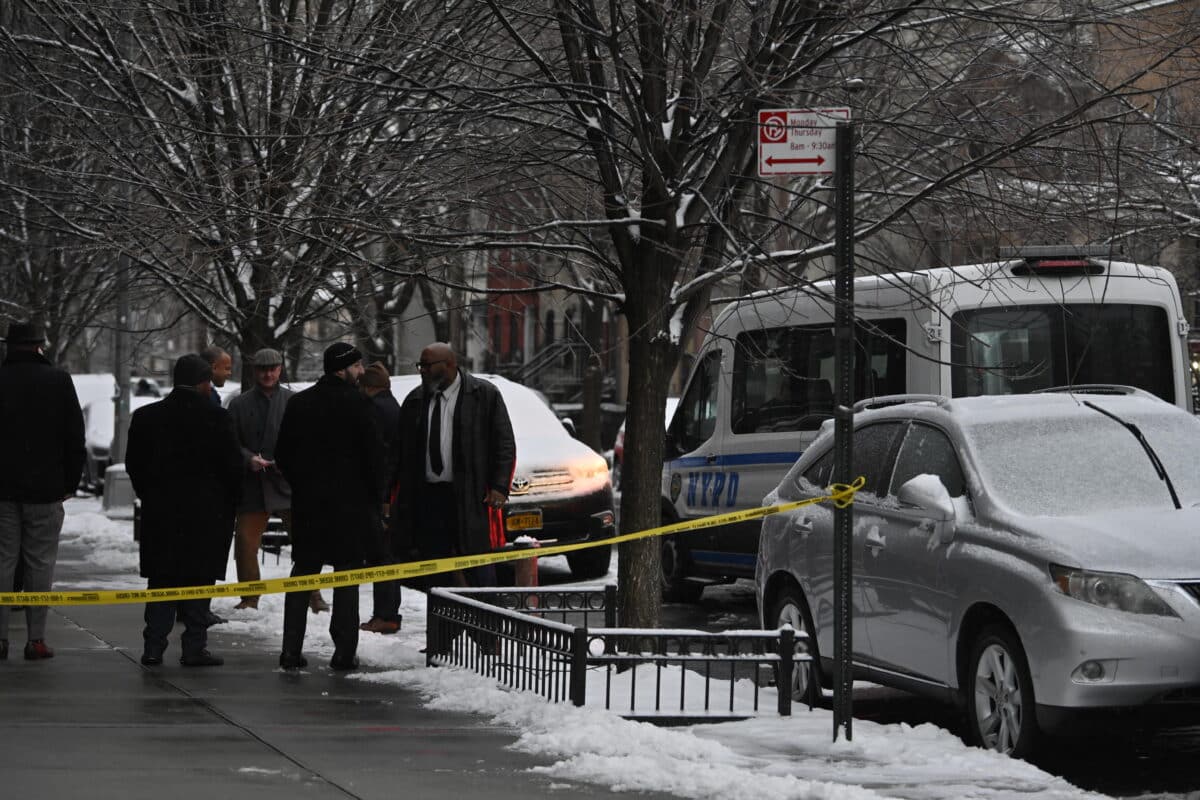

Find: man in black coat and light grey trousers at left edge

[0,323,85,661]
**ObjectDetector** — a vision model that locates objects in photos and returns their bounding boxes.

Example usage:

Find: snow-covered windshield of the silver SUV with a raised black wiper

[966,411,1200,517]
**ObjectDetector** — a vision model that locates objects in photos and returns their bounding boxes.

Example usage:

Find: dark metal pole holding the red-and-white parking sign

[833,121,854,741]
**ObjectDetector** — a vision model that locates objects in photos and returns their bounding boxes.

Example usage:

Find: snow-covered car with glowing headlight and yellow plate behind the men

[391,375,616,579]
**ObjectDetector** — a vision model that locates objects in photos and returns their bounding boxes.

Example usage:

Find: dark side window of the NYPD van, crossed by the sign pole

[730,319,907,433]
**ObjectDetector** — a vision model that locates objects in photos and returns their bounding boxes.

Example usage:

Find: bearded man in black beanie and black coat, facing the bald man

[275,342,384,670]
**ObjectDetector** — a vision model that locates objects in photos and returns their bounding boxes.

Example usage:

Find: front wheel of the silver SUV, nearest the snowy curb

[966,626,1038,758]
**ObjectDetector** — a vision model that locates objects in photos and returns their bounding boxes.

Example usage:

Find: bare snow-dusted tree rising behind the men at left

[0,0,487,376]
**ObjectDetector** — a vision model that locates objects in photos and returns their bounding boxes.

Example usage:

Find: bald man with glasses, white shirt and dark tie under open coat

[392,342,517,587]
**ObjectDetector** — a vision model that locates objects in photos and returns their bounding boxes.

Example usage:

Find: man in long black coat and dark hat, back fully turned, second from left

[125,354,241,667]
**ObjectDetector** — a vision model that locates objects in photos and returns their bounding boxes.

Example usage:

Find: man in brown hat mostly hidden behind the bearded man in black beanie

[359,361,407,633]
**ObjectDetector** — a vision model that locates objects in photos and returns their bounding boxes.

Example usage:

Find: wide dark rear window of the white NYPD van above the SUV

[950,303,1175,403]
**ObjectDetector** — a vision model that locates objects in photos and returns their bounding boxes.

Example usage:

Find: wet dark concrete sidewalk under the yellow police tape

[0,534,667,800]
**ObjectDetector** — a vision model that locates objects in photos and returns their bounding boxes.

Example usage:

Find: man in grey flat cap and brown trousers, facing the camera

[229,348,329,614]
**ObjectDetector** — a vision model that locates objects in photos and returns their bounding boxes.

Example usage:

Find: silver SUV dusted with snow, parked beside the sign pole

[755,387,1200,757]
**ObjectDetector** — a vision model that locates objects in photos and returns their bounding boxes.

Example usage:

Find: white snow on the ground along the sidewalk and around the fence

[55,499,1103,800]
